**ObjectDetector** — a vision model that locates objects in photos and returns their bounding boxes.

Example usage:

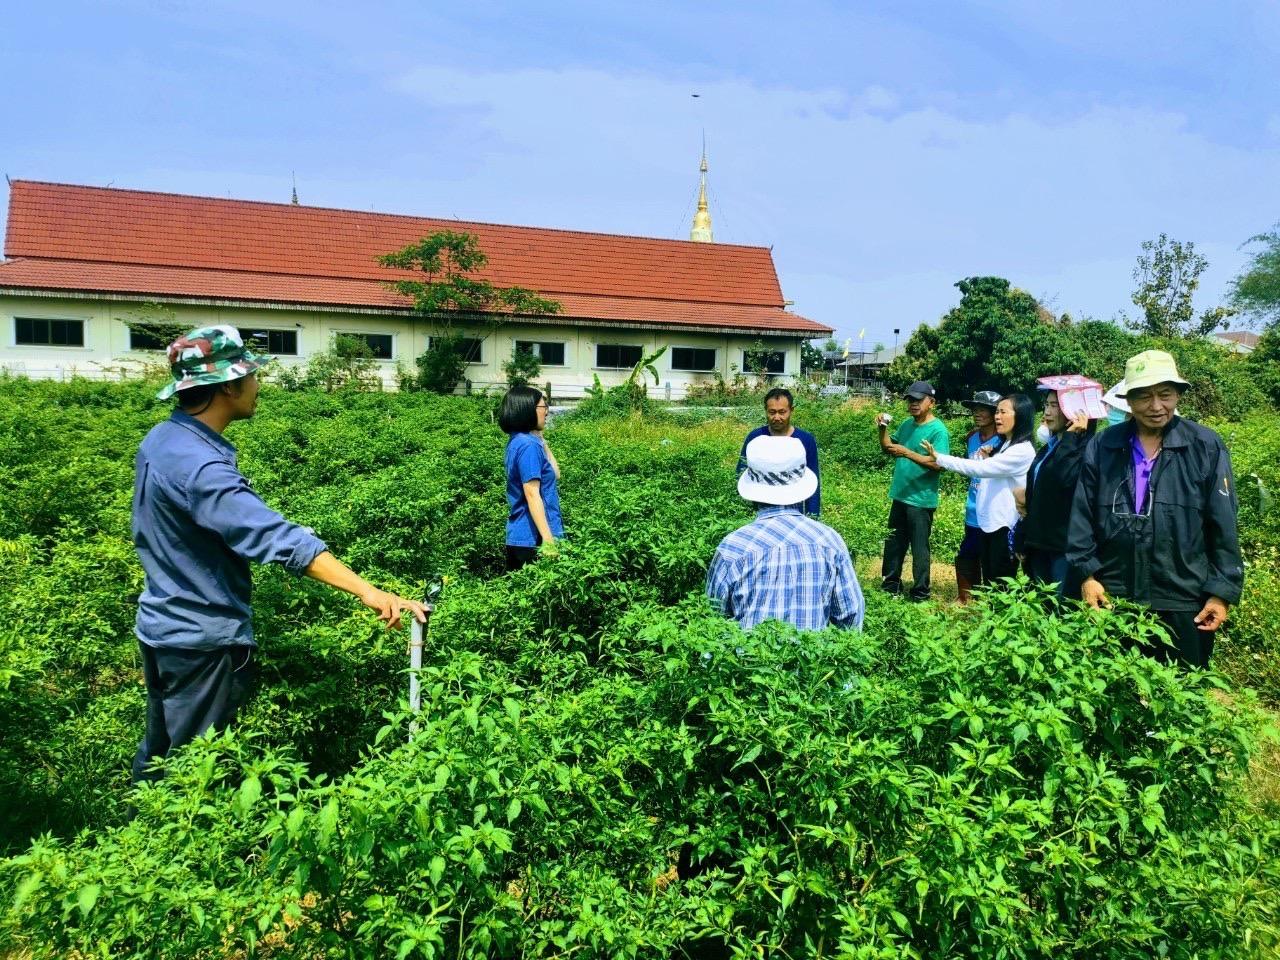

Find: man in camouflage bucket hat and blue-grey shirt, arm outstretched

[133,325,429,781]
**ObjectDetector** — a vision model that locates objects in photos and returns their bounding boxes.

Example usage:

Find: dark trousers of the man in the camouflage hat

[133,644,256,783]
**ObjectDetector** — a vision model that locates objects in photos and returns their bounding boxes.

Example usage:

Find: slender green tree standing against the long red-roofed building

[378,230,561,393]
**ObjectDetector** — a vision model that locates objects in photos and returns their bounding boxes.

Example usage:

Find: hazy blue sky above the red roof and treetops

[0,0,1280,347]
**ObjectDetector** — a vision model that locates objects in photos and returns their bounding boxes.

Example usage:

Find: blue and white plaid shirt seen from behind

[707,507,865,630]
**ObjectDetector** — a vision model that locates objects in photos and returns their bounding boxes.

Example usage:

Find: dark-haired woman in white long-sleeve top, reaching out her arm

[924,393,1036,584]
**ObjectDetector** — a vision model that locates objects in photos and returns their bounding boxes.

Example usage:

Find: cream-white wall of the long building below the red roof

[0,294,801,399]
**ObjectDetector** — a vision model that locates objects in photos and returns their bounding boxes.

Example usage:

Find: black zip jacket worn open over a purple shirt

[1066,417,1244,611]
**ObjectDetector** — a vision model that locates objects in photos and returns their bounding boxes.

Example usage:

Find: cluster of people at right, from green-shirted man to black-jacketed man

[879,351,1244,667]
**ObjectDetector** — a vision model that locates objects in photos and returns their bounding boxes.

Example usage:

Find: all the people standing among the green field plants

[133,325,1243,780]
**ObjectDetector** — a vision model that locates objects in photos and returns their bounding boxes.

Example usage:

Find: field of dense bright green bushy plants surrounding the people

[0,381,1280,957]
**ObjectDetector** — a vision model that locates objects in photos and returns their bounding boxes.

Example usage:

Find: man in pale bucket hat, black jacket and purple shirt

[1066,349,1244,667]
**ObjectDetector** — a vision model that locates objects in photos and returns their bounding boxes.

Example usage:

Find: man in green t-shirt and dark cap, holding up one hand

[877,380,951,600]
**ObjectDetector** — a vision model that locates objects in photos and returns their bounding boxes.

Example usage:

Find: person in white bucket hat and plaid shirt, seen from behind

[707,436,864,630]
